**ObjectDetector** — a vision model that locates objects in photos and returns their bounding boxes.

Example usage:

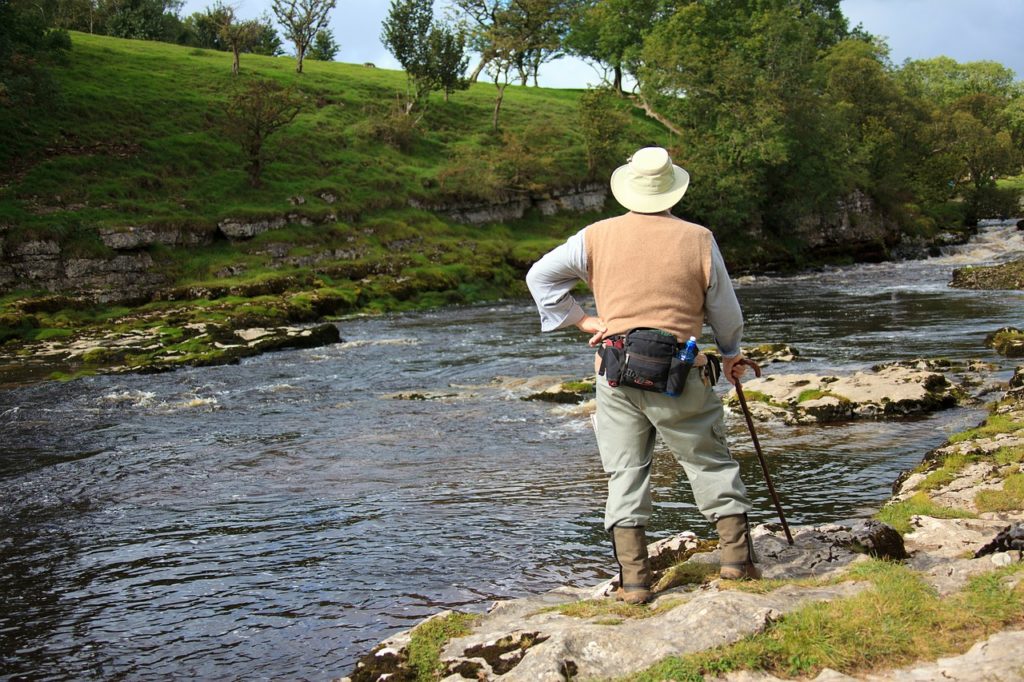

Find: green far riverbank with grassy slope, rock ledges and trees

[0,0,1024,376]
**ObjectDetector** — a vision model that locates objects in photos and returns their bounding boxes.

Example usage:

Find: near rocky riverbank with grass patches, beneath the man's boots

[347,368,1024,682]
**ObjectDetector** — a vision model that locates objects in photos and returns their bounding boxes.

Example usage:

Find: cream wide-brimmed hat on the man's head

[611,146,690,213]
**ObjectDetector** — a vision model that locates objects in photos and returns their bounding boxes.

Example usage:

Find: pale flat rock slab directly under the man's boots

[352,520,903,681]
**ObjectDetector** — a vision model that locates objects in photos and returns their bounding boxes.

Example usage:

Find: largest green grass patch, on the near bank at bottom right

[628,560,1024,682]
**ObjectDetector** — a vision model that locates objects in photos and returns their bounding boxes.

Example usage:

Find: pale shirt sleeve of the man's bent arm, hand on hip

[526,228,587,332]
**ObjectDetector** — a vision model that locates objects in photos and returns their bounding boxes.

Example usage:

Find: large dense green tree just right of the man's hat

[636,0,847,230]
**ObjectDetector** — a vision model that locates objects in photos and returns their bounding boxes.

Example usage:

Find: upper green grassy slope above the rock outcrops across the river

[0,34,664,244]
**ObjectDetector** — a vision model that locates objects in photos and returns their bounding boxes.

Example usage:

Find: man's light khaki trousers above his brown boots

[595,370,751,529]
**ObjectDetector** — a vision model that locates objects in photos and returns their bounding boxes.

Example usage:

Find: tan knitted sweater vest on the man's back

[584,213,712,343]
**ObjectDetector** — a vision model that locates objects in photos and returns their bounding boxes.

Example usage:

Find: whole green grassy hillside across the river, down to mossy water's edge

[0,34,670,370]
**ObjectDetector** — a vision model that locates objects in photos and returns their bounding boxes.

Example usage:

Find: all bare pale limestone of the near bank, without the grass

[343,366,1024,682]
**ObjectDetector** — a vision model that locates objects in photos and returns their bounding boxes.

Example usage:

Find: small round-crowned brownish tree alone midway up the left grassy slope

[227,79,303,187]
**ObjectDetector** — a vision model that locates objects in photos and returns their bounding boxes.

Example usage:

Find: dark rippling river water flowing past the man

[6,224,1024,680]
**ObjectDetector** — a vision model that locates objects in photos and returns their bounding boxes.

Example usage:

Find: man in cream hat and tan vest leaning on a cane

[526,147,761,603]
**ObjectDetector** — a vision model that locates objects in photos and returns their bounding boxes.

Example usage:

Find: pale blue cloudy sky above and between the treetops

[182,0,1024,88]
